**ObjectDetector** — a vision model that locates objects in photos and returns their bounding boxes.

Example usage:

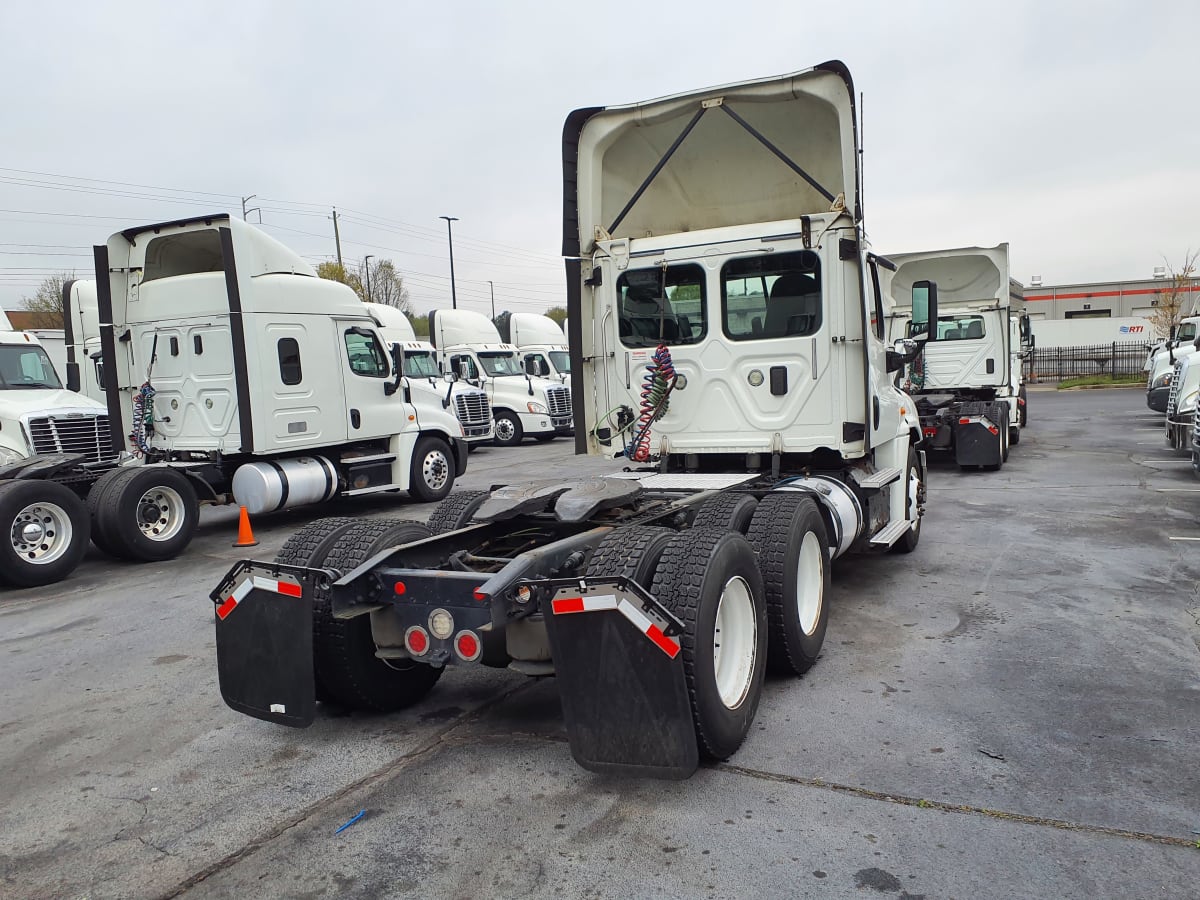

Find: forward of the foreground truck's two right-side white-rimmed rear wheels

[748,492,830,674]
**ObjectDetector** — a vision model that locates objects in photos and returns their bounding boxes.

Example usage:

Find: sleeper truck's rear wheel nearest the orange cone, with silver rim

[94,466,200,563]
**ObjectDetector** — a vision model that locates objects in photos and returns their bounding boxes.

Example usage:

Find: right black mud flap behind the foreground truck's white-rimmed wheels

[542,578,700,779]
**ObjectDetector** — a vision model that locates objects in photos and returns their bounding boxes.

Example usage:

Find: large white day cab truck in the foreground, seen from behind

[210,62,937,778]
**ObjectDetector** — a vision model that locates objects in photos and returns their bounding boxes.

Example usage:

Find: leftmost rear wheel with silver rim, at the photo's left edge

[0,479,91,588]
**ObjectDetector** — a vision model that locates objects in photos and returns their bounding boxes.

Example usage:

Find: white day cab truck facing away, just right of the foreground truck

[886,244,1033,469]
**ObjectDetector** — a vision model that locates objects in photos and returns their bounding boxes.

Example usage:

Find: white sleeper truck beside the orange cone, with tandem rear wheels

[0,215,467,584]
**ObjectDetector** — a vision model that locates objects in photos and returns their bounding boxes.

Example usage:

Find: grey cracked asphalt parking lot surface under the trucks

[0,390,1200,898]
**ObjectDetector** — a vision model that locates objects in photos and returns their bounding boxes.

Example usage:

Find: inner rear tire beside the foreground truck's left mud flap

[312,520,443,713]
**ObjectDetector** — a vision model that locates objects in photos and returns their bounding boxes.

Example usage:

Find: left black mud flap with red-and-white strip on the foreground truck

[210,562,324,728]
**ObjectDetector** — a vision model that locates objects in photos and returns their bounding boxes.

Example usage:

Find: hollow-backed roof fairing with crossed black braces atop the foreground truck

[563,62,862,256]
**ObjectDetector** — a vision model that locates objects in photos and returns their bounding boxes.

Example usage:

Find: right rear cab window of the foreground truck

[721,250,822,341]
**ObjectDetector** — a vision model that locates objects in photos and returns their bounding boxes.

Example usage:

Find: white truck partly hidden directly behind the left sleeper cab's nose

[366,304,496,445]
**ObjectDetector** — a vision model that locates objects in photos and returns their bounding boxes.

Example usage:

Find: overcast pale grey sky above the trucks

[0,0,1200,312]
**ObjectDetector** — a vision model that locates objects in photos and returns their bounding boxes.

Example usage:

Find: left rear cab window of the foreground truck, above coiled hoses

[617,263,708,347]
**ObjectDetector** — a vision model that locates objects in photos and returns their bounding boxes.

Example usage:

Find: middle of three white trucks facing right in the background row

[430,310,571,446]
